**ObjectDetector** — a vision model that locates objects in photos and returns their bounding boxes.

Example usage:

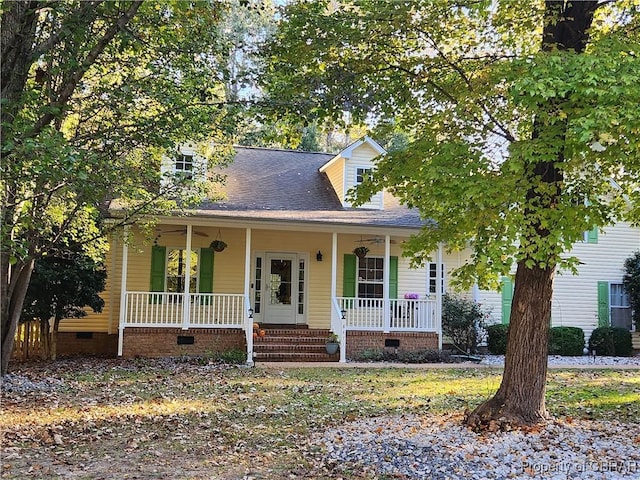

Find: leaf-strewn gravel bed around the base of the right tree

[314,415,640,480]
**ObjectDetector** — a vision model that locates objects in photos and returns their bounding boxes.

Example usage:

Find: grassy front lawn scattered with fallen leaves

[0,359,640,480]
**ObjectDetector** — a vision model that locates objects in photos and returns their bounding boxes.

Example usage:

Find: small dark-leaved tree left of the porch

[22,248,107,360]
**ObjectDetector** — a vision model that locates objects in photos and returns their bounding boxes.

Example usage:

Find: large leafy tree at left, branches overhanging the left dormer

[0,0,232,374]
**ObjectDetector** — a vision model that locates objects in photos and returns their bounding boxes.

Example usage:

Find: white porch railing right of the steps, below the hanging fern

[336,297,438,332]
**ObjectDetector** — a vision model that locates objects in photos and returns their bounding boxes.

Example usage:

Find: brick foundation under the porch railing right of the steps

[347,331,438,359]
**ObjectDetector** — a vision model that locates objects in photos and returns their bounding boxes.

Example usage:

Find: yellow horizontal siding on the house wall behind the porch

[79,226,448,333]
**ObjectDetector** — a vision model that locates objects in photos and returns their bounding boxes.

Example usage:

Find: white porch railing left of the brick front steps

[122,292,247,329]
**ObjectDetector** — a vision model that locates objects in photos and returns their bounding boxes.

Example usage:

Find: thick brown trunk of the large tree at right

[466,0,598,429]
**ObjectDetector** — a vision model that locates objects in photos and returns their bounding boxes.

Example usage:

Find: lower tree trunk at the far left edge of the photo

[0,253,35,376]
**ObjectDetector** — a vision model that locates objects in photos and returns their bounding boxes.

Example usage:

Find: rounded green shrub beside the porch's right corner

[442,294,488,353]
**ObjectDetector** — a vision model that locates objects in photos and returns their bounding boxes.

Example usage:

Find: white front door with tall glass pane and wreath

[264,253,298,324]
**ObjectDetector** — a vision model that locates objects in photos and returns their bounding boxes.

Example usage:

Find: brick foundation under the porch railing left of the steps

[122,327,247,358]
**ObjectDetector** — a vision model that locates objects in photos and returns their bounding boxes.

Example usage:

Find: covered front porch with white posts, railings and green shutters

[118,223,443,363]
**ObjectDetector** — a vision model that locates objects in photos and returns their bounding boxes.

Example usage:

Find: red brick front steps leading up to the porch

[253,325,340,363]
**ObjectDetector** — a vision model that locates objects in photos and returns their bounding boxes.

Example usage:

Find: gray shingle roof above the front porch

[194,147,423,228]
